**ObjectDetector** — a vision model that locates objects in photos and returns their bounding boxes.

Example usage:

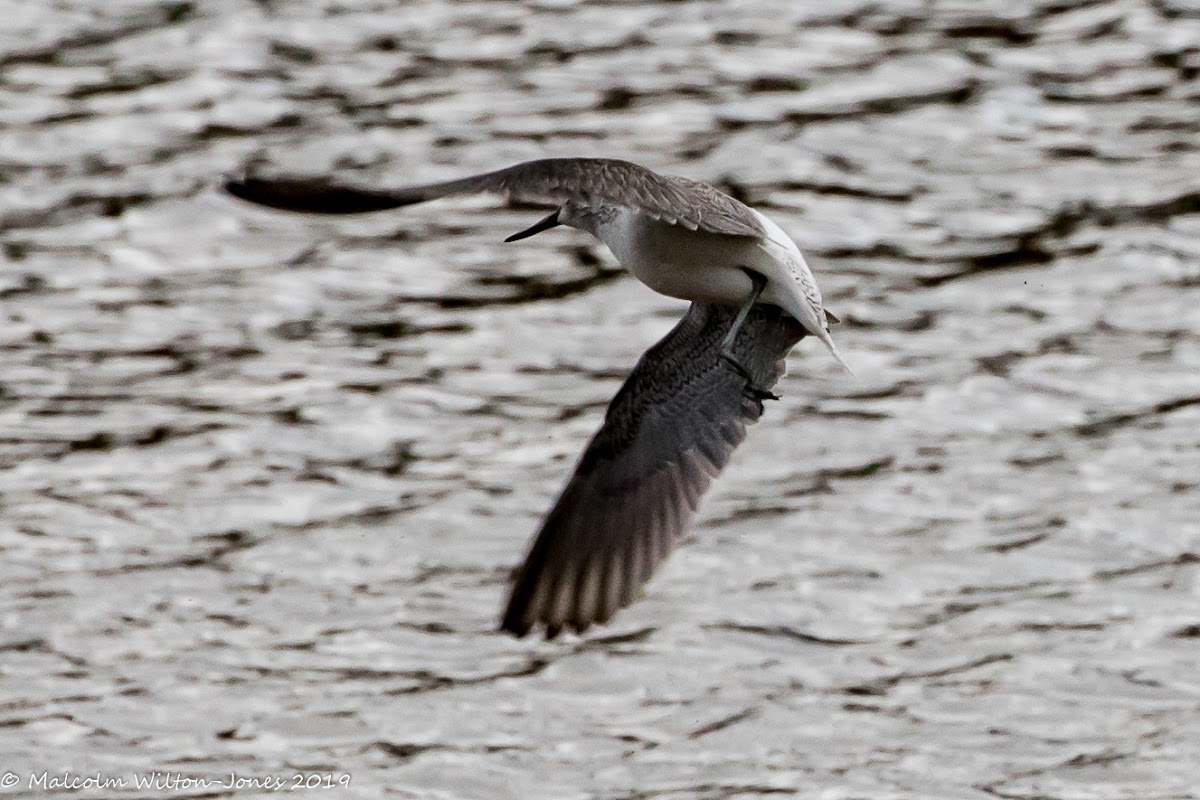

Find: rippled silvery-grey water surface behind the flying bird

[0,0,1200,800]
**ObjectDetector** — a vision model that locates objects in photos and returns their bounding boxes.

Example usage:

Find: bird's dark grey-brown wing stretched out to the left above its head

[226,158,763,236]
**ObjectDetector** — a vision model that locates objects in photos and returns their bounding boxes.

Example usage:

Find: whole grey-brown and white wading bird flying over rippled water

[226,158,853,638]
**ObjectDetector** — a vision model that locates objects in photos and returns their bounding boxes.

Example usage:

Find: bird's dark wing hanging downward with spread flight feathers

[500,303,804,637]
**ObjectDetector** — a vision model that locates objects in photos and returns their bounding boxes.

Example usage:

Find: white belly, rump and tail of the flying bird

[594,209,854,374]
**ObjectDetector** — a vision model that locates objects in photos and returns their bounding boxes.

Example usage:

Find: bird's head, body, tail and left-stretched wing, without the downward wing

[226,158,853,374]
